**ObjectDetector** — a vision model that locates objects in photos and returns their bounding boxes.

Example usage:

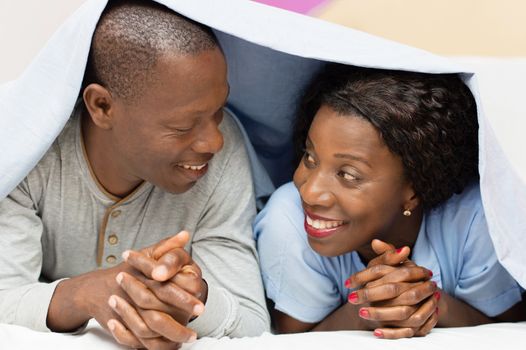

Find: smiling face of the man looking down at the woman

[111,49,228,193]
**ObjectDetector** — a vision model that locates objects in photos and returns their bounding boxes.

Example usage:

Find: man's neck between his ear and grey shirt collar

[81,115,142,200]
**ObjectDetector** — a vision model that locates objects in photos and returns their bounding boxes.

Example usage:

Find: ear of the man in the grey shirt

[82,84,115,130]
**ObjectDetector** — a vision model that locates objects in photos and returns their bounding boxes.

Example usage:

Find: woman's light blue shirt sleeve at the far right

[455,194,521,317]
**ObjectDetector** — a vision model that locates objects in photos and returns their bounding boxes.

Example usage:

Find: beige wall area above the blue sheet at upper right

[318,0,526,56]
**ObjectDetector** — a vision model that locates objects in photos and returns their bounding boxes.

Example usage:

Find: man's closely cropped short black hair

[81,0,218,100]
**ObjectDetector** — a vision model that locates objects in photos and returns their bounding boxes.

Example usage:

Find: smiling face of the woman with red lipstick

[294,106,414,256]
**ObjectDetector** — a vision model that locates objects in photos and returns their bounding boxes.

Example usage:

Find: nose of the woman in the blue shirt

[299,171,336,207]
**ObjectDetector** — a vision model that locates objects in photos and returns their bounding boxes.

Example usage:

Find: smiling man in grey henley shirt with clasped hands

[0,1,268,348]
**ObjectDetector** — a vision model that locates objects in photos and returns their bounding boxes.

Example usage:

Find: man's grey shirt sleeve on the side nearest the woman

[189,120,270,337]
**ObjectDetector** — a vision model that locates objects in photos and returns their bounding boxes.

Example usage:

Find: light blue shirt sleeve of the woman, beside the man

[254,183,341,323]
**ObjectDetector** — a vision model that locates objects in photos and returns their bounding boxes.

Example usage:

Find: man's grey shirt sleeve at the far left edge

[0,179,60,331]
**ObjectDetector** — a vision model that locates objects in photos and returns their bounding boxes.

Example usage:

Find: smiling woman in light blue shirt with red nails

[254,65,524,338]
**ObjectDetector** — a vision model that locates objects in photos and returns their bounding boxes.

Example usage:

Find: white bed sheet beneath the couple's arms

[0,321,526,350]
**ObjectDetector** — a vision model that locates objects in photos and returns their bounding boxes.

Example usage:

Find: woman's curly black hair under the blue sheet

[294,64,478,209]
